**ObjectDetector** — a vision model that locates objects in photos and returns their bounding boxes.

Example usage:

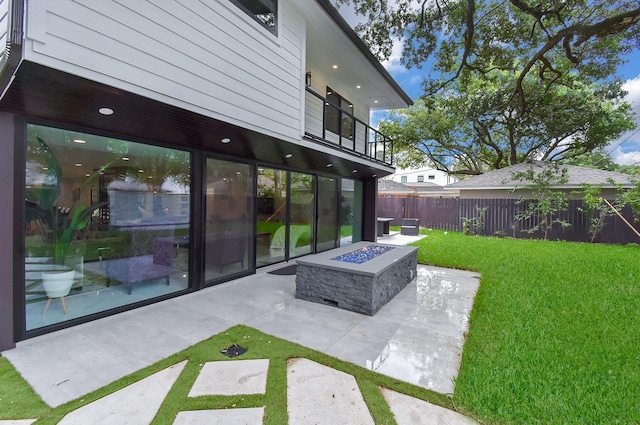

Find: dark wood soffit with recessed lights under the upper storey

[0,61,390,179]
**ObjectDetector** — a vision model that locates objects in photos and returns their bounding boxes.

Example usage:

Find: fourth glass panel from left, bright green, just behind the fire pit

[289,172,315,258]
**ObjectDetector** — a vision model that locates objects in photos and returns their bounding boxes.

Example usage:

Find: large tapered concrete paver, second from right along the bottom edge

[287,359,374,425]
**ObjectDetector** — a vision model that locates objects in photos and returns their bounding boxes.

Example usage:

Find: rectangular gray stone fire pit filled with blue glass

[296,242,418,316]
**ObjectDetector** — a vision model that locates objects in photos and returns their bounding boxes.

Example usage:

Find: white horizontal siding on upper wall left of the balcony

[23,0,304,139]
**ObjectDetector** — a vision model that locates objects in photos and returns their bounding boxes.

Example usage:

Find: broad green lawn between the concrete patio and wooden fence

[418,231,640,424]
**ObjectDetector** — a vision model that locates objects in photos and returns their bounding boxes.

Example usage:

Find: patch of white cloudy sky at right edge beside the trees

[609,74,640,165]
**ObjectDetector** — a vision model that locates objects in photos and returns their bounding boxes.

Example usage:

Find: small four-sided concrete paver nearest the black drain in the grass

[189,359,269,397]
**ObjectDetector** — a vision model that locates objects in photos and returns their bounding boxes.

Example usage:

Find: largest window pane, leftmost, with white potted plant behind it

[25,125,191,330]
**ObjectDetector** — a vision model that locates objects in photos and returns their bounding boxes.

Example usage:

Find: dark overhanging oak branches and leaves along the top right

[334,0,640,114]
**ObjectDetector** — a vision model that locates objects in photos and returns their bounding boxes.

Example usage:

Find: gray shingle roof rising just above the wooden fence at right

[446,161,636,190]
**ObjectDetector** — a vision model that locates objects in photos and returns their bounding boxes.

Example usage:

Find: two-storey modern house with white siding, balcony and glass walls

[0,0,411,350]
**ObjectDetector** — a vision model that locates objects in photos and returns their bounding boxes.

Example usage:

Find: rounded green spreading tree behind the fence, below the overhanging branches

[380,75,633,176]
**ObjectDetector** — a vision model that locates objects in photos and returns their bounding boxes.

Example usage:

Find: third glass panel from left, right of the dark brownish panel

[256,167,288,266]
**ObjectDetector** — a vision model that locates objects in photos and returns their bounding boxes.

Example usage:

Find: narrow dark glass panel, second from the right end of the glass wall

[316,176,338,252]
